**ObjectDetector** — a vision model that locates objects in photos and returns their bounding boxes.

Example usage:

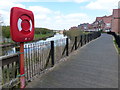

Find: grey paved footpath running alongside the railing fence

[27,34,118,88]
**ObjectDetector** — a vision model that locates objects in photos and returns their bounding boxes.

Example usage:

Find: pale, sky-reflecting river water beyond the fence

[3,33,67,55]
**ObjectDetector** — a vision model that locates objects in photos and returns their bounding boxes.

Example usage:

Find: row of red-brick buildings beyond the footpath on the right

[70,7,120,34]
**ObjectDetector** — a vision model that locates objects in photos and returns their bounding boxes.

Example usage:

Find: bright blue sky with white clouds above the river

[0,0,119,30]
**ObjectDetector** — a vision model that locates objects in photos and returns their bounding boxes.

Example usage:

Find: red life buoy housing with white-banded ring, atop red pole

[10,7,34,42]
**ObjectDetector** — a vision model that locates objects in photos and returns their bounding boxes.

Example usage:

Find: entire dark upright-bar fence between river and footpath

[0,32,101,88]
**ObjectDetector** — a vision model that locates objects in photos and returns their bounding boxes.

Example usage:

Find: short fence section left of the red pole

[0,54,20,88]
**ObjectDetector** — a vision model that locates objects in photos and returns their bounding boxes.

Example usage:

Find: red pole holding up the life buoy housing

[20,42,25,88]
